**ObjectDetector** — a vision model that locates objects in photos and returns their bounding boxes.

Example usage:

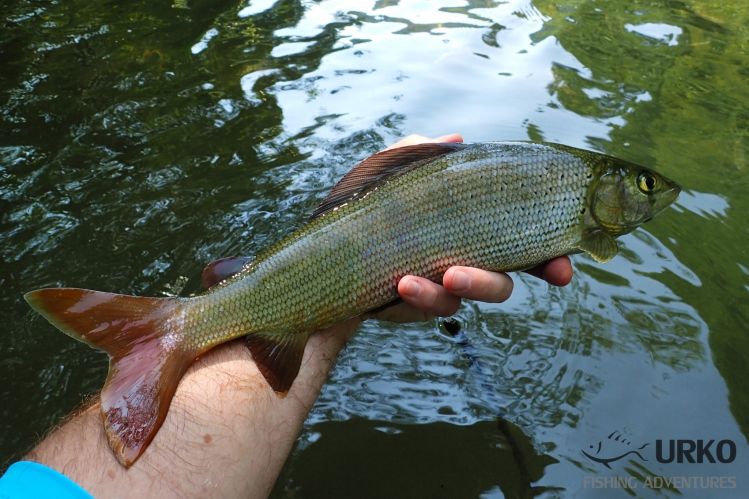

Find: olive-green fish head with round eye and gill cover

[588,162,681,236]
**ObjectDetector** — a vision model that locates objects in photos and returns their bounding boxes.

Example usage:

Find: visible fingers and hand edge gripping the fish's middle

[372,133,572,322]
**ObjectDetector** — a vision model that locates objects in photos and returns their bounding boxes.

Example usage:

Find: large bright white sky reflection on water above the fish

[258,1,623,146]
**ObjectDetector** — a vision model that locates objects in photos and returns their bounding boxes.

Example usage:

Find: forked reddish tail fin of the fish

[24,288,193,467]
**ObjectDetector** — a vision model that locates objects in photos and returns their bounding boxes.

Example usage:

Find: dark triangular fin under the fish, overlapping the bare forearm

[245,333,311,395]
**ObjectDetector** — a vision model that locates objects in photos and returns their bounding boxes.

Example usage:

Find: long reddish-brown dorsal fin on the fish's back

[311,142,467,219]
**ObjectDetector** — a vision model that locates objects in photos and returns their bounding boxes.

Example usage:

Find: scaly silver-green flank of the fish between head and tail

[180,143,591,349]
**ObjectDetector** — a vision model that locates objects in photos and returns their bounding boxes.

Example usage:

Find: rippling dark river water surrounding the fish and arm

[0,0,749,497]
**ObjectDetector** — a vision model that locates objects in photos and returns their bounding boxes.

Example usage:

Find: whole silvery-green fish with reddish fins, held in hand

[26,142,679,466]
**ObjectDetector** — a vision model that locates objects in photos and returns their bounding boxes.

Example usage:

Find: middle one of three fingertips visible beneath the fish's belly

[442,267,513,303]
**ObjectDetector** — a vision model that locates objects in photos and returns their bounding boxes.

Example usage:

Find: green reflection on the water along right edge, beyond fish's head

[535,1,749,435]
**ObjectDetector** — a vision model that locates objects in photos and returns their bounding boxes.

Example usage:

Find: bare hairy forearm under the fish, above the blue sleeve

[27,320,359,497]
